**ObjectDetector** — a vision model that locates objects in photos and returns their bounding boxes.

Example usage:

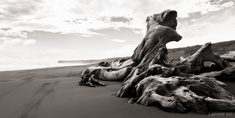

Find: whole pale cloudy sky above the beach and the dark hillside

[0,0,235,63]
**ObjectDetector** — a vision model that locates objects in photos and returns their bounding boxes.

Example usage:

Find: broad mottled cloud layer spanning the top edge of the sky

[0,0,234,36]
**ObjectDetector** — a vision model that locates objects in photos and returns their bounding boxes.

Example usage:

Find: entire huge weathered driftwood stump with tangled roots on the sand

[79,10,235,114]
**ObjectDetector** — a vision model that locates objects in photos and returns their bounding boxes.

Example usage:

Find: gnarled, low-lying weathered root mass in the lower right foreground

[129,75,235,113]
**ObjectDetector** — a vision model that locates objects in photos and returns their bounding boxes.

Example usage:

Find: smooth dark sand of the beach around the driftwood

[0,66,235,118]
